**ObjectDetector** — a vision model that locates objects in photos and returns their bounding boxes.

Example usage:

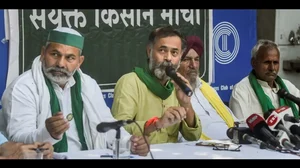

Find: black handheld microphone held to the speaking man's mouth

[166,66,193,97]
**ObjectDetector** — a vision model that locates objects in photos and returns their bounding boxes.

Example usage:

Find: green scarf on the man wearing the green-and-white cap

[44,71,87,152]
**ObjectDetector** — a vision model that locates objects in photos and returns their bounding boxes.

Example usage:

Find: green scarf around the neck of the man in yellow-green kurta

[133,67,174,100]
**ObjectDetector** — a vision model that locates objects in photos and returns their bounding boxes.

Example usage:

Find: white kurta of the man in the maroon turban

[180,78,237,139]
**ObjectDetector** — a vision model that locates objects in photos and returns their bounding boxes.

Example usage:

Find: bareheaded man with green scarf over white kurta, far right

[229,40,300,120]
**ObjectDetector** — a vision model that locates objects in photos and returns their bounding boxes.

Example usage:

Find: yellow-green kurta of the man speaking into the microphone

[112,72,202,144]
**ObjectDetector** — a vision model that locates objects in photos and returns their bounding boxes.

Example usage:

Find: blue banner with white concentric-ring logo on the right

[211,10,257,102]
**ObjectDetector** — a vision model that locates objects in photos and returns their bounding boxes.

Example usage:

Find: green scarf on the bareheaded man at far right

[248,70,299,119]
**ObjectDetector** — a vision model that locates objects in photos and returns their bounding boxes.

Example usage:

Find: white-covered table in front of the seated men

[60,142,300,159]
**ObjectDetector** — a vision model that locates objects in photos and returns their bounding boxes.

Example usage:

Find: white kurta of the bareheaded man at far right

[229,76,300,121]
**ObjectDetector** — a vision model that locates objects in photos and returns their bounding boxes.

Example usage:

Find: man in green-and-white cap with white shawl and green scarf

[2,27,149,156]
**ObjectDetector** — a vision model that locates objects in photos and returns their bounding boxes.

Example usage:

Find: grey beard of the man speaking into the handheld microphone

[149,50,180,81]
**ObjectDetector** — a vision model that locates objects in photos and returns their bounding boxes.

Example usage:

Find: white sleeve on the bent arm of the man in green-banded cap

[2,78,59,144]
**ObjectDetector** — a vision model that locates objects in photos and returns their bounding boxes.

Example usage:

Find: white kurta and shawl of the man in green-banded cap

[2,57,131,151]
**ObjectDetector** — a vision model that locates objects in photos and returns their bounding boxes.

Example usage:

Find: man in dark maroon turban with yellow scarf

[178,36,237,140]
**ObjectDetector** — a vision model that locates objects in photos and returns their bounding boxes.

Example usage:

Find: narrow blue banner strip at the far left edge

[0,9,8,109]
